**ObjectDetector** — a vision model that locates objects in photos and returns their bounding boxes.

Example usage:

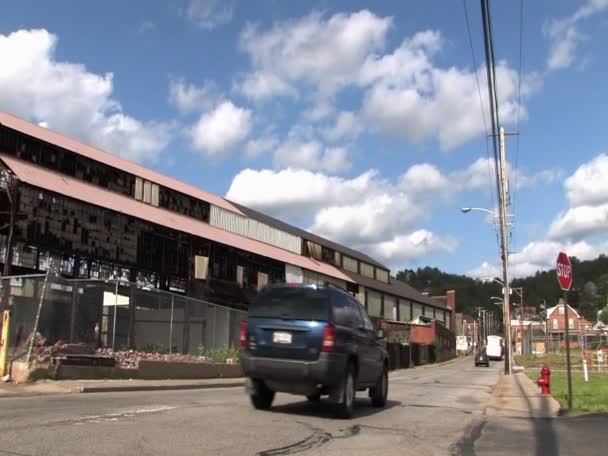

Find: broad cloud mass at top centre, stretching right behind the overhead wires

[235,10,541,150]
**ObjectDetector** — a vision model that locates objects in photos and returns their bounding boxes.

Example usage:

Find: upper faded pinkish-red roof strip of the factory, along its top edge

[0,111,244,215]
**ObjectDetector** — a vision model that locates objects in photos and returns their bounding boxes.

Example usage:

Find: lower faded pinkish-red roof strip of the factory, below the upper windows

[0,154,353,282]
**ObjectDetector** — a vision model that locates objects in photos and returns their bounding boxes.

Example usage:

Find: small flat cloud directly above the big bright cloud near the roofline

[274,140,351,173]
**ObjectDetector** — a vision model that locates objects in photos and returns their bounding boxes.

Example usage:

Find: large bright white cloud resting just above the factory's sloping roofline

[226,165,456,266]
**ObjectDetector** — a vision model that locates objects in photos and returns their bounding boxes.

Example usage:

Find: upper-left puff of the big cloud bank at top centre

[235,10,392,99]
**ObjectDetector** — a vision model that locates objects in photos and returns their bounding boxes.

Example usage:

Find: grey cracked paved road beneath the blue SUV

[0,359,498,456]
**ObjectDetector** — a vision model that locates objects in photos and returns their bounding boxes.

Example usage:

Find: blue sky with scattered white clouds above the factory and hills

[0,0,608,276]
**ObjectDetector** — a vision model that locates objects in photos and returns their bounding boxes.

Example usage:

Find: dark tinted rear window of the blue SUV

[249,288,330,321]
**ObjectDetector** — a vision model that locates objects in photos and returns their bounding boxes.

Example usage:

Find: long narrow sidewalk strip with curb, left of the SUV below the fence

[0,378,245,398]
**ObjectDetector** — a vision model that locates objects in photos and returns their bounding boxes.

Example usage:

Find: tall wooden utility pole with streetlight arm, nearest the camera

[499,127,513,375]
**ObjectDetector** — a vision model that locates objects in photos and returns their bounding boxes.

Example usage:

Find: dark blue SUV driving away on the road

[240,284,388,418]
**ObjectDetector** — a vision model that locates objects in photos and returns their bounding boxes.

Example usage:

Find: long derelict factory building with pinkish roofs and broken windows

[0,113,454,329]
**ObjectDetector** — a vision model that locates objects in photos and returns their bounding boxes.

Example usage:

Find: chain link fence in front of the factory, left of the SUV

[0,273,246,364]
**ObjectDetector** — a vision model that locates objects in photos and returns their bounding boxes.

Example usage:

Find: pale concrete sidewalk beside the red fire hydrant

[486,373,560,418]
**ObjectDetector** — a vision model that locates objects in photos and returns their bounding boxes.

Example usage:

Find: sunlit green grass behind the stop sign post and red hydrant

[528,372,608,415]
